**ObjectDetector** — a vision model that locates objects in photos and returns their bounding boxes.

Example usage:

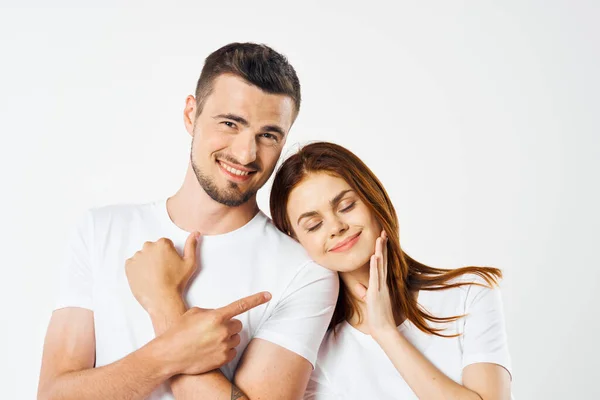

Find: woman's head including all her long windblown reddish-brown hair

[270,142,502,336]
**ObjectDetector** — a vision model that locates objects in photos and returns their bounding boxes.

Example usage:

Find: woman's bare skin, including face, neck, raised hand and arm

[287,173,510,400]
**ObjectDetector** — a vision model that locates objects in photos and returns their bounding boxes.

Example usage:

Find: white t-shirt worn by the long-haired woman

[305,274,511,400]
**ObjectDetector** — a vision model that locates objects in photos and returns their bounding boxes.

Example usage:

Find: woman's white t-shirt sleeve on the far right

[462,278,512,376]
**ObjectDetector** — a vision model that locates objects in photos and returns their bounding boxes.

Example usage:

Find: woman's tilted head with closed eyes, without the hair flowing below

[271,142,396,272]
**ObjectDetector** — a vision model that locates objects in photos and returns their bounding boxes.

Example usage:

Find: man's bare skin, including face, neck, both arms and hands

[38,75,311,400]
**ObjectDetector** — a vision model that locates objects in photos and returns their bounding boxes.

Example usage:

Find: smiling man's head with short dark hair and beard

[184,43,301,207]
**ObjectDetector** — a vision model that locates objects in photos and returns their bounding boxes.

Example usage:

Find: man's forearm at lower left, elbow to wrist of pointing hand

[38,340,173,400]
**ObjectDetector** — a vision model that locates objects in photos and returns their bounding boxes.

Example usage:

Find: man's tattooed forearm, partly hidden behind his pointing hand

[150,298,248,400]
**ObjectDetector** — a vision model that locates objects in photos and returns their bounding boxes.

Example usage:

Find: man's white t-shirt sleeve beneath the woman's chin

[254,261,339,368]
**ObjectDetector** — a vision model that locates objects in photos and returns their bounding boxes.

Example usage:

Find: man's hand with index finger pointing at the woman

[157,292,271,375]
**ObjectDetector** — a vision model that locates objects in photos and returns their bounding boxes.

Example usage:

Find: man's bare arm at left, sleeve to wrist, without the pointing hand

[38,307,175,400]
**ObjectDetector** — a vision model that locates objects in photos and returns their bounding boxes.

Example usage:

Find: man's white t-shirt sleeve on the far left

[54,211,93,310]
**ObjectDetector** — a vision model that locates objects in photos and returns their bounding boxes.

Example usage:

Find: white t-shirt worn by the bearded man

[56,201,338,399]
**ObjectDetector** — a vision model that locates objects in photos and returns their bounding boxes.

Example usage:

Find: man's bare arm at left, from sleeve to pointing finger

[38,300,247,399]
